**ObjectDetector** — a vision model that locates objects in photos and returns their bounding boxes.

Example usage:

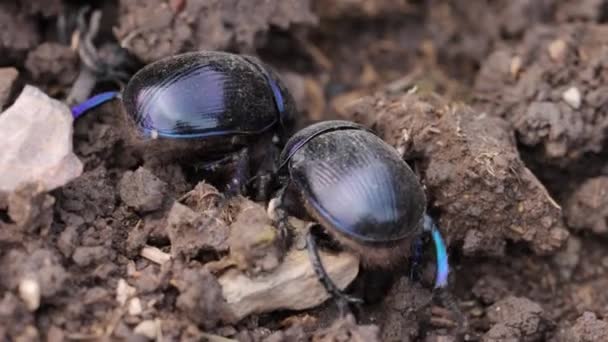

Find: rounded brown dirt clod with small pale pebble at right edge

[475,24,608,167]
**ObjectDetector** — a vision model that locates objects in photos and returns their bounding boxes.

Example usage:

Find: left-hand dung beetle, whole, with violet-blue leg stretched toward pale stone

[72,51,296,196]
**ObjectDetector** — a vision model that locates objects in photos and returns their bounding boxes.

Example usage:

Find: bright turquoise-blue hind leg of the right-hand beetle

[424,213,466,331]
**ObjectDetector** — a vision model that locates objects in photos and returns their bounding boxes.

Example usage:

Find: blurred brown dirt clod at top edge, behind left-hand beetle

[116,0,316,62]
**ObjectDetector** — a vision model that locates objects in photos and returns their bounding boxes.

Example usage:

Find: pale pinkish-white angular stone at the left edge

[0,86,83,192]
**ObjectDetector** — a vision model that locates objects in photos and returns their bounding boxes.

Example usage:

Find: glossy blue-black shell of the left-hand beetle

[123,51,295,138]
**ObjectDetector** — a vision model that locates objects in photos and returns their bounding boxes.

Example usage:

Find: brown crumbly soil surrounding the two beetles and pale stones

[0,0,608,341]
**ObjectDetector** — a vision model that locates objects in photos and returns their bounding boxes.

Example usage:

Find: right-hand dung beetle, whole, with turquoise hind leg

[271,120,456,316]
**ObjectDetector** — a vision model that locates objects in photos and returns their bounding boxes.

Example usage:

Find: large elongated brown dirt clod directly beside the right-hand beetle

[344,94,568,255]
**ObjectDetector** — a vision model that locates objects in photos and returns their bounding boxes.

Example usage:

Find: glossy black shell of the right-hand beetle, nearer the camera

[281,121,426,242]
